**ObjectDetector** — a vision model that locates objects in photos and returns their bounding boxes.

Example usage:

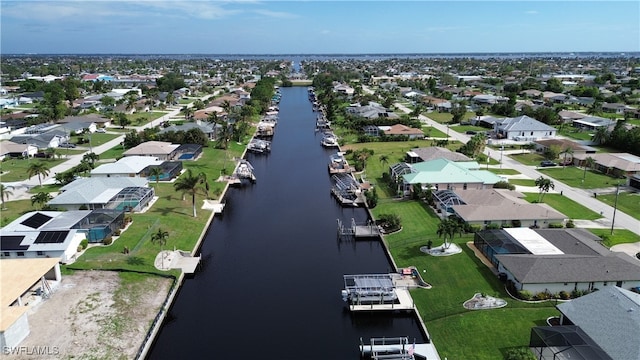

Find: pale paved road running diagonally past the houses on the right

[395,104,640,235]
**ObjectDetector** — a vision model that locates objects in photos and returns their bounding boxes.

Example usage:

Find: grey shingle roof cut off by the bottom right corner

[557,286,640,359]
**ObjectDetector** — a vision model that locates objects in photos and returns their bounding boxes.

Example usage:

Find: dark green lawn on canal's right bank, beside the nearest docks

[372,199,557,359]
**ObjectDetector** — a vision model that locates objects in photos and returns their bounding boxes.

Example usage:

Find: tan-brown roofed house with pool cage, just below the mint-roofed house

[433,189,568,228]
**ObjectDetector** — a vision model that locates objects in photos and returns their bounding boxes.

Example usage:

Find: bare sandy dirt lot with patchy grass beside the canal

[8,271,172,360]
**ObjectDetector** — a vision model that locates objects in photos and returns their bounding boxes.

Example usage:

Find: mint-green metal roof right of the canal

[402,159,502,184]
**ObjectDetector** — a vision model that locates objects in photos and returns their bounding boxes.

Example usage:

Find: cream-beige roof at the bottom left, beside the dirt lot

[0,258,60,332]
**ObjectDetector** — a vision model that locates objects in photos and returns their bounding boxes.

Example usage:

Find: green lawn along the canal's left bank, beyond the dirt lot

[68,142,244,275]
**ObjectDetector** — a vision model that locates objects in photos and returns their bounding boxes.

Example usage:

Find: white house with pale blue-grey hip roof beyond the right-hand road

[493,115,557,141]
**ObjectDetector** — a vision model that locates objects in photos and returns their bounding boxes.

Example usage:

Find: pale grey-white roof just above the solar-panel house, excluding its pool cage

[48,176,148,205]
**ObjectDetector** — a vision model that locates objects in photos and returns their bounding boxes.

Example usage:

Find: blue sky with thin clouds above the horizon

[0,0,640,54]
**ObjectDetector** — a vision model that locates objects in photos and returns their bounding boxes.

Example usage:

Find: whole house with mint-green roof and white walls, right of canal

[402,159,502,195]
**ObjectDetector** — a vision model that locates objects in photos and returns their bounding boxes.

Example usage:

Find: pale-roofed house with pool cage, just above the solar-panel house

[47,177,155,211]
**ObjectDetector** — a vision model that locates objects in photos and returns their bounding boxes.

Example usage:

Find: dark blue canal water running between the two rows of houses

[149,87,424,360]
